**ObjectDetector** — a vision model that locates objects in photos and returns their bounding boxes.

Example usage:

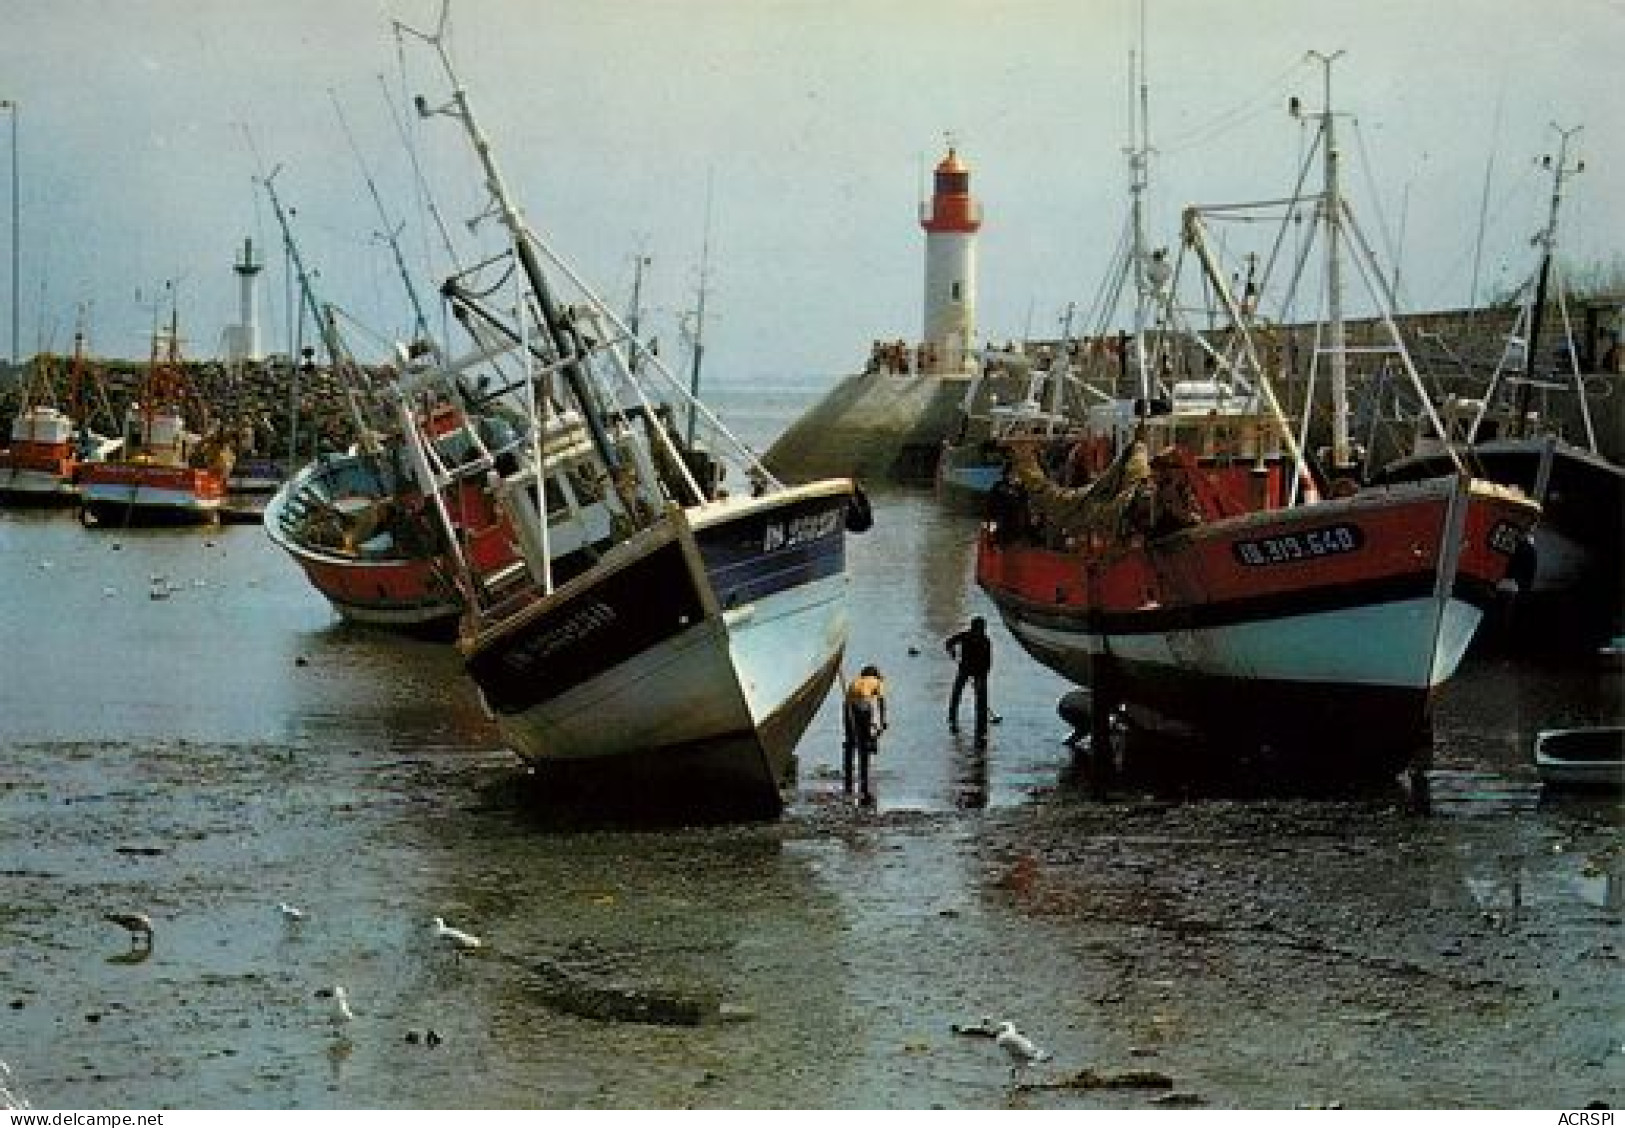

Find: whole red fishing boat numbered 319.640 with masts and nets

[977,59,1539,777]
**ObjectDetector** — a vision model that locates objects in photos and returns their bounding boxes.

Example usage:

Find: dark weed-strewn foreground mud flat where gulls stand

[0,740,1625,1108]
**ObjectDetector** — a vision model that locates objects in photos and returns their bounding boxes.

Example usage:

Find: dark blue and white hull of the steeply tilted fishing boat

[465,483,850,818]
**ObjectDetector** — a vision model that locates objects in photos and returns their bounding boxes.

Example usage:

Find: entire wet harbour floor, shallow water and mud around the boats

[0,502,1625,1108]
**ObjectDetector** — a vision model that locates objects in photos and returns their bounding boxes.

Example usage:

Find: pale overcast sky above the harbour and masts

[0,0,1625,387]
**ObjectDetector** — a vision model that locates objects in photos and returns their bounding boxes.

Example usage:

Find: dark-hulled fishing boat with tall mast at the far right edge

[1373,132,1625,649]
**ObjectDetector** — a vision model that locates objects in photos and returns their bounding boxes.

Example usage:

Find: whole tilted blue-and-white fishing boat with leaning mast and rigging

[393,13,868,818]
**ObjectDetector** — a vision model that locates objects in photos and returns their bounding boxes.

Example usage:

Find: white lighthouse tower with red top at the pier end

[920,145,982,374]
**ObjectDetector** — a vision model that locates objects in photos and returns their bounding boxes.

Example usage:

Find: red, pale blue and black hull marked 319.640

[978,479,1536,772]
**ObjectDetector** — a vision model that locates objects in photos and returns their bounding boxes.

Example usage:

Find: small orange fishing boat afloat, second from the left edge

[80,310,232,527]
